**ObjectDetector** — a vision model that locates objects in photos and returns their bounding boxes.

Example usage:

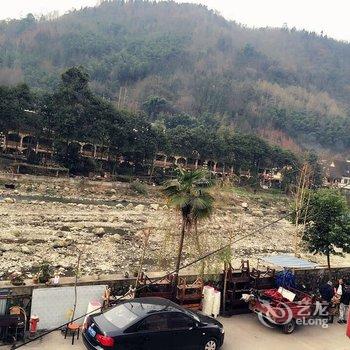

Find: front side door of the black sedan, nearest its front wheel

[167,312,204,350]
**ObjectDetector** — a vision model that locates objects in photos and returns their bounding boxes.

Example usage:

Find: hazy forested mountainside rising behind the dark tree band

[0,0,350,153]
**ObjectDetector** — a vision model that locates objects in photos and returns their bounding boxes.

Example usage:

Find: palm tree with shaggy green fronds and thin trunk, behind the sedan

[164,168,214,279]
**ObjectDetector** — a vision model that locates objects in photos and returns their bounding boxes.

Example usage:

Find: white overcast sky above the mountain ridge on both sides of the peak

[0,0,350,41]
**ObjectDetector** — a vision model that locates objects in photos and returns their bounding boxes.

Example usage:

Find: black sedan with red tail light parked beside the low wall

[83,298,224,350]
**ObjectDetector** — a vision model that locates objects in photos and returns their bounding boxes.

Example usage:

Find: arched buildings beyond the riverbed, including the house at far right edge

[0,131,350,190]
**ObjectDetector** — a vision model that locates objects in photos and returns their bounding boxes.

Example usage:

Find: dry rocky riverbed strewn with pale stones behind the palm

[0,177,336,278]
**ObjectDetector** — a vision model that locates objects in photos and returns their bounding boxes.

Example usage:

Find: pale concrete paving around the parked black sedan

[6,314,350,350]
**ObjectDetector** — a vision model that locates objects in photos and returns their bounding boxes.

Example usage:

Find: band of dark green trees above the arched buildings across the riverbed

[0,67,298,173]
